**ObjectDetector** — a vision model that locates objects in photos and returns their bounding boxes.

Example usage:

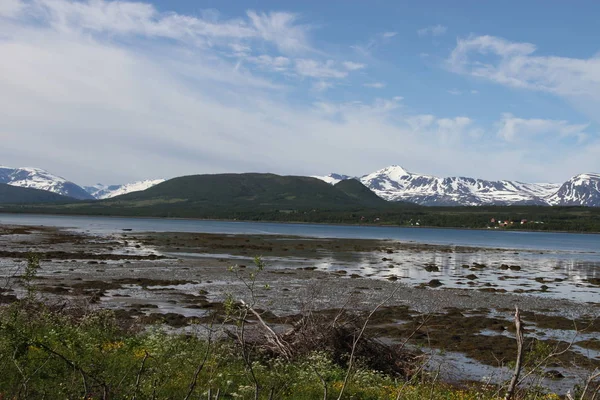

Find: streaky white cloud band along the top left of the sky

[15,0,310,53]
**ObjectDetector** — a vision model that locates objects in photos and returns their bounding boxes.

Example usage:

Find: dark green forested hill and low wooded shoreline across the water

[0,174,600,232]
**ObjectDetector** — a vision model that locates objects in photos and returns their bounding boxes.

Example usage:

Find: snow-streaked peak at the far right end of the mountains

[548,174,600,207]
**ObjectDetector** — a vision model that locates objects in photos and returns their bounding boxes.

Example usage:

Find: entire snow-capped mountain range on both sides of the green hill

[0,165,600,207]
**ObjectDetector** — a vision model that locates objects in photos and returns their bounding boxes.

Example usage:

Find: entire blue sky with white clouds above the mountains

[0,0,600,184]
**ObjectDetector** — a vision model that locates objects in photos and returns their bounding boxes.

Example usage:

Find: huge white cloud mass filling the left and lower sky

[0,0,600,184]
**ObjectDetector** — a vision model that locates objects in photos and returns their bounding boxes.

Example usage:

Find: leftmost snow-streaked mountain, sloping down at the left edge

[0,166,93,200]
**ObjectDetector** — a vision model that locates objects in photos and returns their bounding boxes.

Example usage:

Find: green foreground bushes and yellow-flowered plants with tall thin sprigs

[0,258,572,400]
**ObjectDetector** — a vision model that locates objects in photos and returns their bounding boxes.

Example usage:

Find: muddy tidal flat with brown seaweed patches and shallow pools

[0,225,600,392]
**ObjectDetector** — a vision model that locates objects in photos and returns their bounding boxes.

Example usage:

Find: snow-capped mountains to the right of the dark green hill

[316,165,600,207]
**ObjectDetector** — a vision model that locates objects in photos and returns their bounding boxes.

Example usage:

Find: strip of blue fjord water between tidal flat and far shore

[0,214,600,253]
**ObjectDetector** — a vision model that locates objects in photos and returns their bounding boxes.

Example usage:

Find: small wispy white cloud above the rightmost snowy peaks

[497,113,589,142]
